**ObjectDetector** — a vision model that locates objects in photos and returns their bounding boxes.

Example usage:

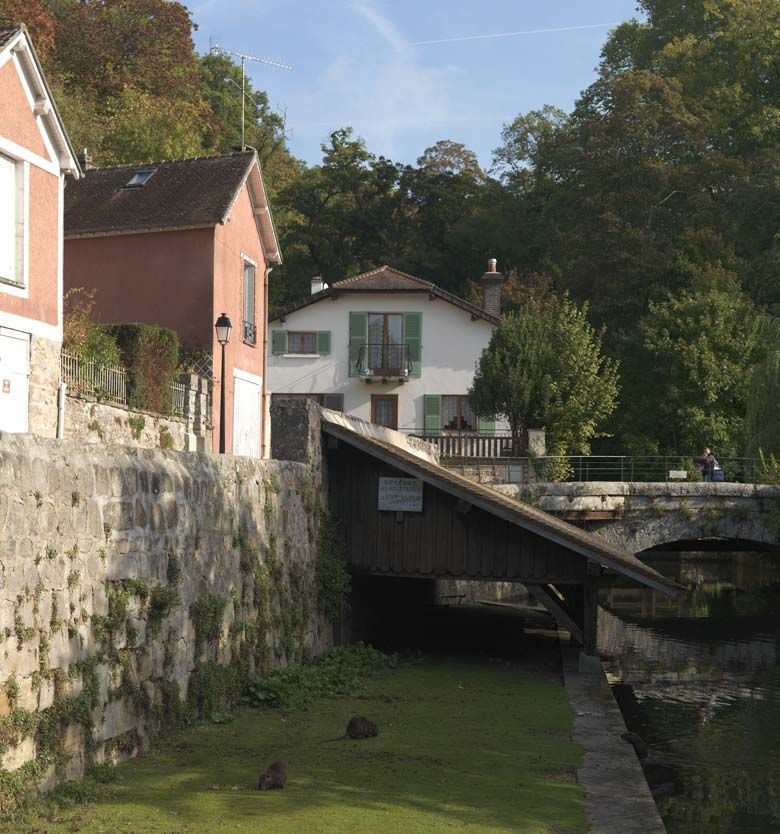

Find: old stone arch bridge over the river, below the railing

[493,481,780,553]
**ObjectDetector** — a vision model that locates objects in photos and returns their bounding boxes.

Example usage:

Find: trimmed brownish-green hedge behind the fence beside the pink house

[111,323,179,412]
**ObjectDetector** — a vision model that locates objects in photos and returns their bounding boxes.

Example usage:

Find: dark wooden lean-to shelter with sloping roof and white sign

[322,411,680,654]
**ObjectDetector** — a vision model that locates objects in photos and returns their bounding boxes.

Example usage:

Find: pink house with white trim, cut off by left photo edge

[0,26,81,437]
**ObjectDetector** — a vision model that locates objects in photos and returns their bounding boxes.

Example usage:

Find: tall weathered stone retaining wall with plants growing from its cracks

[0,398,332,812]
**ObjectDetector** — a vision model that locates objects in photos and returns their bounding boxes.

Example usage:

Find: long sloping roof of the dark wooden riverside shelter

[322,420,682,596]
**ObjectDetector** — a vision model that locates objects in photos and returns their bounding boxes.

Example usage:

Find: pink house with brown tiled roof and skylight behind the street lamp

[65,150,281,457]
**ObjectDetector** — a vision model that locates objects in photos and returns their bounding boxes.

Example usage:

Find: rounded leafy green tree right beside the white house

[469,296,618,455]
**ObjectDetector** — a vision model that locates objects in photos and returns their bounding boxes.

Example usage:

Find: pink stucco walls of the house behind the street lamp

[65,176,266,451]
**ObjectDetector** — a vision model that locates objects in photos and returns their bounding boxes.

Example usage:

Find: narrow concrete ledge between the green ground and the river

[561,634,667,834]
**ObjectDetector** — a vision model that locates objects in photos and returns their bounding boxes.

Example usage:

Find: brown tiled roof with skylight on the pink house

[65,151,255,236]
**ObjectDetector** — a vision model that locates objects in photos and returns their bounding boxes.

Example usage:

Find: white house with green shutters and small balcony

[268,260,520,456]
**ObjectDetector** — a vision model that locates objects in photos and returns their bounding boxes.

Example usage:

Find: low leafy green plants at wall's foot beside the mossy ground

[245,644,397,709]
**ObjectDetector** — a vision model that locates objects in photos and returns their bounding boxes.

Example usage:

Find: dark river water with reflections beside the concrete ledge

[599,552,780,834]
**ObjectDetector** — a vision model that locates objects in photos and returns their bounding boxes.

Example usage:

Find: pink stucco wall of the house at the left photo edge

[0,61,61,326]
